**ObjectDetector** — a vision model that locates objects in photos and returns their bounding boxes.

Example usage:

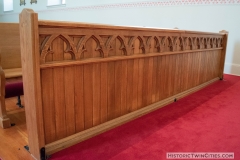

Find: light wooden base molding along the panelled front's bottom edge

[45,77,220,155]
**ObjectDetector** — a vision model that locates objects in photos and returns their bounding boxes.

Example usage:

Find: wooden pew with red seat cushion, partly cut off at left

[0,23,22,128]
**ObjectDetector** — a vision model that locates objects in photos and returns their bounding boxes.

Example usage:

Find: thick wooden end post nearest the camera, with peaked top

[19,9,45,159]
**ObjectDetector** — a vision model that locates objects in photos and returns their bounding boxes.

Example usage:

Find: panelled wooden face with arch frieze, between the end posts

[36,23,223,144]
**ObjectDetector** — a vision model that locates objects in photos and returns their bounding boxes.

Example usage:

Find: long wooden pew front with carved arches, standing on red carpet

[20,9,228,159]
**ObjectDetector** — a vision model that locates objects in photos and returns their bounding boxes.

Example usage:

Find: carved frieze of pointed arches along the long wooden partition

[39,34,222,64]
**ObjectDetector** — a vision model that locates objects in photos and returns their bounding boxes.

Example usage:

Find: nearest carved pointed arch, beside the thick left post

[40,34,77,64]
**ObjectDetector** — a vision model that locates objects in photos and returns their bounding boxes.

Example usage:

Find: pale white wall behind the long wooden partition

[0,0,240,75]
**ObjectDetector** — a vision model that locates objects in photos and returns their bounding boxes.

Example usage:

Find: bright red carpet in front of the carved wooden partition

[50,75,240,160]
